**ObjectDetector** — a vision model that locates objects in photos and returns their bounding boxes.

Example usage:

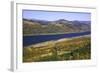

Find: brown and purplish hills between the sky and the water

[23,19,91,35]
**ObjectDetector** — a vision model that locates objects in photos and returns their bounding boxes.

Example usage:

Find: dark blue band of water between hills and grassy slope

[23,32,91,46]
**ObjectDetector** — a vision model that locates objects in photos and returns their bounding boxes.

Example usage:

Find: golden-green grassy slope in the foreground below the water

[23,36,91,63]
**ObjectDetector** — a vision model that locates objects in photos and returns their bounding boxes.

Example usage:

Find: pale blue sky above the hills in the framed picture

[22,10,91,21]
